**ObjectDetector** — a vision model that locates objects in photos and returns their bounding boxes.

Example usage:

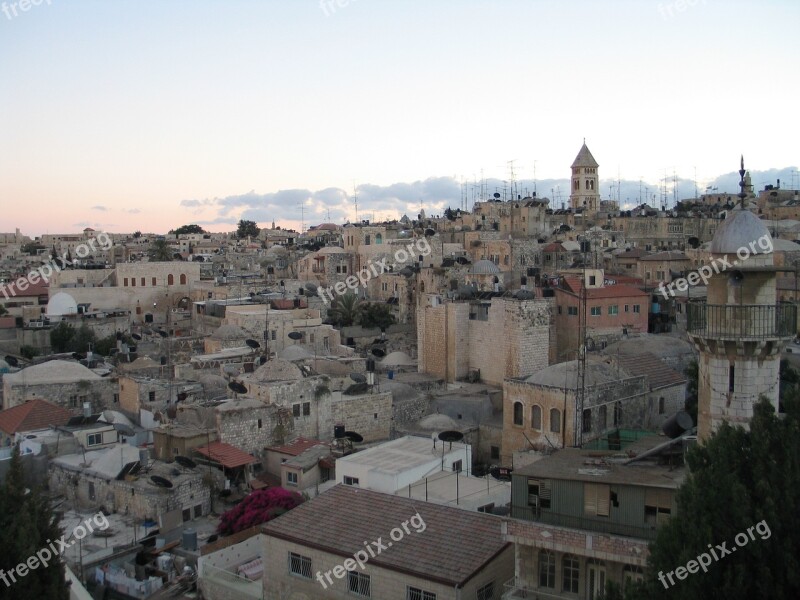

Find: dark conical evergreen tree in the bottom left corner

[0,448,69,600]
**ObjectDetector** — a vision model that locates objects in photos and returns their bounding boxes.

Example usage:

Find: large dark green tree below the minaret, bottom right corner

[639,393,800,600]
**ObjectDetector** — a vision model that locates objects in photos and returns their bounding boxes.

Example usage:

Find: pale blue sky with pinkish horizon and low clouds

[0,0,800,235]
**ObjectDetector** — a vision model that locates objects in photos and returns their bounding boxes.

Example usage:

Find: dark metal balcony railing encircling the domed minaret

[686,302,797,340]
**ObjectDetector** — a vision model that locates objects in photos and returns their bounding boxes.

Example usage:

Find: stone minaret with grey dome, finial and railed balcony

[687,158,797,439]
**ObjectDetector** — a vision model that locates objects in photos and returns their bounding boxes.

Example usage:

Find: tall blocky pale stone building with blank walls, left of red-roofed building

[417,295,552,385]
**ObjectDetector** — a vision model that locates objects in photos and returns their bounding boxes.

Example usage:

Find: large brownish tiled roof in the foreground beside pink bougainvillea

[263,485,509,586]
